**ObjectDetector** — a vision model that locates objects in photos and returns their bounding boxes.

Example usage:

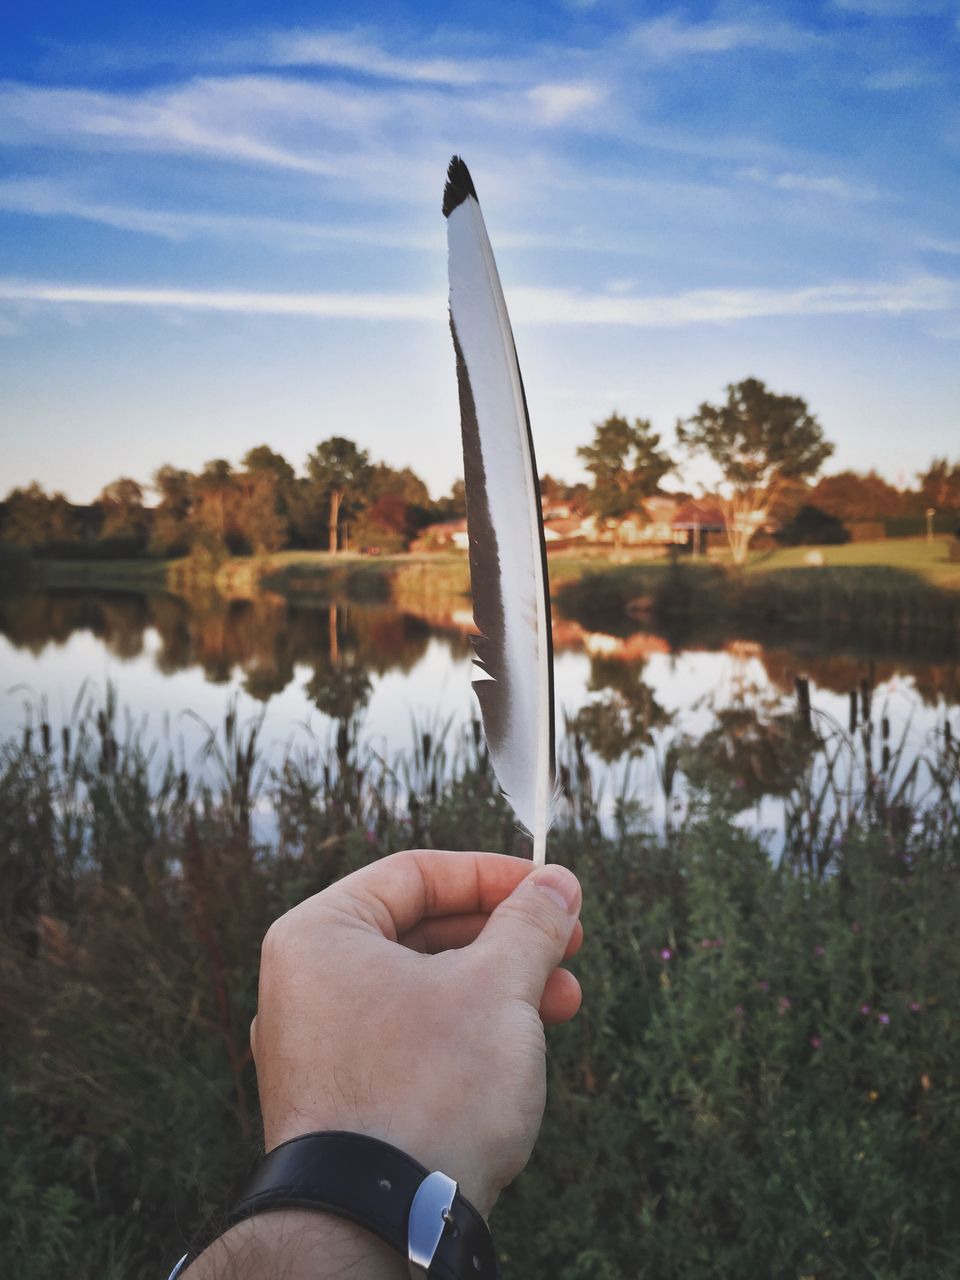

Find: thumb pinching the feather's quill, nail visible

[475,863,581,1009]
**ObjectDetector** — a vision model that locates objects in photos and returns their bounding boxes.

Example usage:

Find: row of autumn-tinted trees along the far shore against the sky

[0,378,960,563]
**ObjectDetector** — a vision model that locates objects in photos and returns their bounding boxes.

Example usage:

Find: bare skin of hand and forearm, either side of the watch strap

[187,850,582,1280]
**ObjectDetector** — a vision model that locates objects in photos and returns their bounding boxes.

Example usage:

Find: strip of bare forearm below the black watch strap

[184,1210,410,1280]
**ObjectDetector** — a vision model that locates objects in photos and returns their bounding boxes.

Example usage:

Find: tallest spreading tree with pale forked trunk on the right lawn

[677,378,833,564]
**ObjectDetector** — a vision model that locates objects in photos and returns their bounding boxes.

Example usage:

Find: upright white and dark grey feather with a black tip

[443,156,556,863]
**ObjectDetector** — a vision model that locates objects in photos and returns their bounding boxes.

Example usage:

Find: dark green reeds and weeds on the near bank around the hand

[0,707,960,1280]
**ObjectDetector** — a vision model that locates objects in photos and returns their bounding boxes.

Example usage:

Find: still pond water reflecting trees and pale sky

[0,590,960,837]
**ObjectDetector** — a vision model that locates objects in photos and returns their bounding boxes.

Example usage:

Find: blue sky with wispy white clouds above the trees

[0,0,960,502]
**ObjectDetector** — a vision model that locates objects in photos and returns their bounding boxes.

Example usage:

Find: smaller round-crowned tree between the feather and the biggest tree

[577,413,673,541]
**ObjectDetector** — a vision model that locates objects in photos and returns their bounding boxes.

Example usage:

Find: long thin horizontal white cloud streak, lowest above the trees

[0,276,957,329]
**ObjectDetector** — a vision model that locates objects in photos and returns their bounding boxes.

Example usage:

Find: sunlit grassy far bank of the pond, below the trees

[6,538,960,654]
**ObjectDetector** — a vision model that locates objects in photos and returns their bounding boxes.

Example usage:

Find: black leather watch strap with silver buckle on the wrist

[218,1130,499,1280]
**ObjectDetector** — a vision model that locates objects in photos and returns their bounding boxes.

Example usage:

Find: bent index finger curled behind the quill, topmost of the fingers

[319,849,545,942]
